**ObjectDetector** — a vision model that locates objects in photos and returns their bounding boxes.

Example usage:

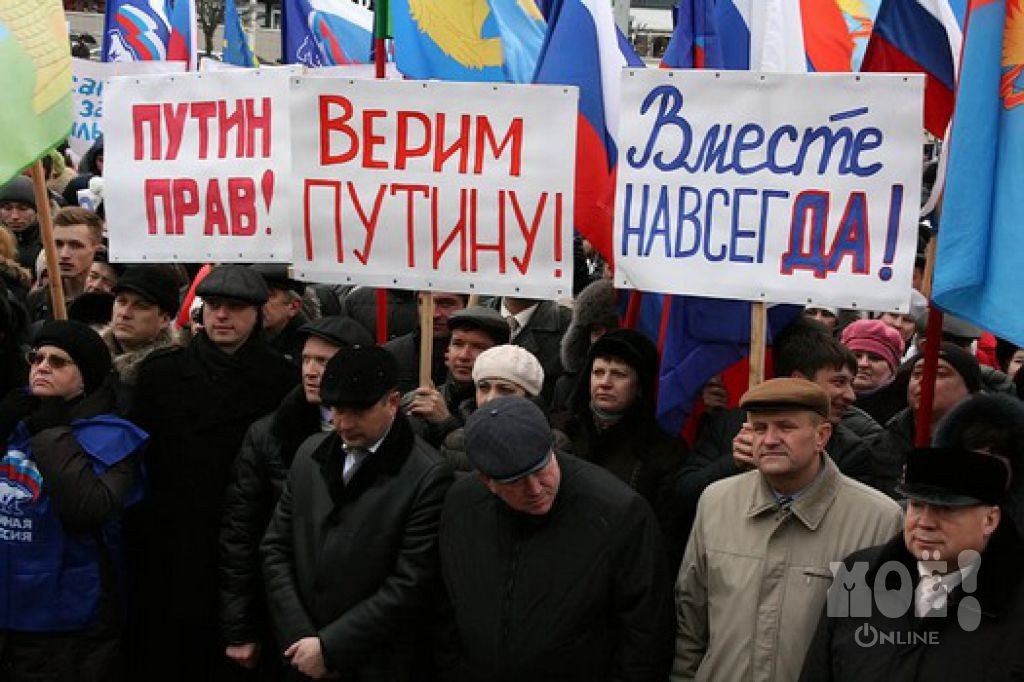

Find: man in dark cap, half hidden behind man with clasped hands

[220,315,374,678]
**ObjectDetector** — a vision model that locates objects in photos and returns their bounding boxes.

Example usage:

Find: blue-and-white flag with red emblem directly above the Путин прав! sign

[100,0,171,61]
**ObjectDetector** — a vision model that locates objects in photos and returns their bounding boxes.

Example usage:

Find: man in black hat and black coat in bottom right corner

[801,449,1024,682]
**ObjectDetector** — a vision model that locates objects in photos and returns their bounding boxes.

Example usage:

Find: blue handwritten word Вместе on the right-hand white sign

[626,85,885,177]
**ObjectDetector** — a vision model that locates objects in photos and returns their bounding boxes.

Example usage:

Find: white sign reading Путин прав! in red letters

[103,69,292,262]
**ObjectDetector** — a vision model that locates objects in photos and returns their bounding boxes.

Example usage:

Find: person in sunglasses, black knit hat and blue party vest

[0,321,147,682]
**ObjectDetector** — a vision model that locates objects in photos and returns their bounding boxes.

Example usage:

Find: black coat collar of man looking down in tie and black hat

[312,412,416,507]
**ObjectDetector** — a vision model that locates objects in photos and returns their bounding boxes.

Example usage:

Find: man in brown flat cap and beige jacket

[672,378,901,681]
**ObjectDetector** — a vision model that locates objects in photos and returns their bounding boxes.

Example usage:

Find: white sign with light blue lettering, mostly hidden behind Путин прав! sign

[68,57,185,159]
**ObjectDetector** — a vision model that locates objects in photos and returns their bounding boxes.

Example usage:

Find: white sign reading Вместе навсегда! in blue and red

[613,69,924,311]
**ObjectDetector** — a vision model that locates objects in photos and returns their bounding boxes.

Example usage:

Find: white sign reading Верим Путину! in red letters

[291,77,577,298]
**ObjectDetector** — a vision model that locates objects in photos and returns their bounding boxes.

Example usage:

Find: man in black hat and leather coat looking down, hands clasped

[261,346,453,682]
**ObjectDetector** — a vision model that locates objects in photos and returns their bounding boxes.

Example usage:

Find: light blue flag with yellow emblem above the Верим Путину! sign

[390,0,547,83]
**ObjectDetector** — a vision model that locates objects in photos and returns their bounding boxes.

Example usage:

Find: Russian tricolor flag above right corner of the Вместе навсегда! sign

[861,0,964,137]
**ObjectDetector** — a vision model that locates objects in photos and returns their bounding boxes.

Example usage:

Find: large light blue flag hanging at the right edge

[932,0,1024,345]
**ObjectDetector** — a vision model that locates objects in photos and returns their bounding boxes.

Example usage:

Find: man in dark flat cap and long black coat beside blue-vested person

[128,265,298,682]
